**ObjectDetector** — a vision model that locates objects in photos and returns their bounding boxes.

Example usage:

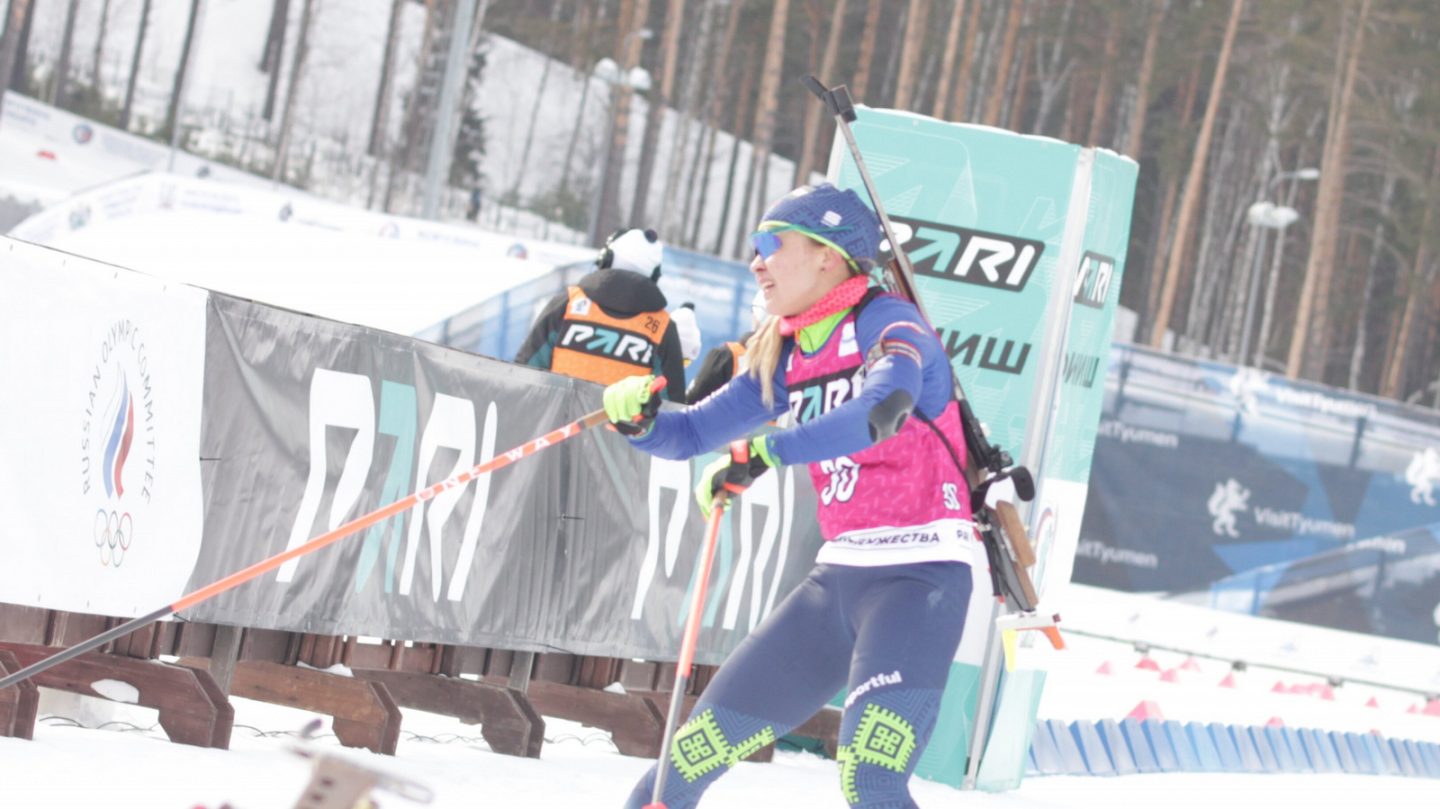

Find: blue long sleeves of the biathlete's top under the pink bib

[632,295,952,464]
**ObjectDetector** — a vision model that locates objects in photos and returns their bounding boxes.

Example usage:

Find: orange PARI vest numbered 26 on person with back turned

[550,286,670,384]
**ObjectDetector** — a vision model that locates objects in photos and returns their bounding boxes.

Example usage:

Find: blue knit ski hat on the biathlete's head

[757,183,884,269]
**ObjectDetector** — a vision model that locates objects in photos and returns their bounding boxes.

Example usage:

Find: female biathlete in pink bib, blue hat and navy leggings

[605,183,985,809]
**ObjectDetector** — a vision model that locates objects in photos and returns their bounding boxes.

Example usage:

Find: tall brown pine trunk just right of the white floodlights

[1286,0,1369,381]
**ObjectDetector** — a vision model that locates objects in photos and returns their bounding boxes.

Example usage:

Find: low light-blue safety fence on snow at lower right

[1027,718,1440,779]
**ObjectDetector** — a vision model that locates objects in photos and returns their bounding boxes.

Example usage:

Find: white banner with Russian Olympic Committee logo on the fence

[0,239,207,616]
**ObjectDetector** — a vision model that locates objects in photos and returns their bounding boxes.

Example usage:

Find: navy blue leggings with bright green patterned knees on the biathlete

[626,561,972,809]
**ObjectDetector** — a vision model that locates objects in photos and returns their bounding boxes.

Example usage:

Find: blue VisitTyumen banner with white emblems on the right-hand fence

[1074,345,1440,643]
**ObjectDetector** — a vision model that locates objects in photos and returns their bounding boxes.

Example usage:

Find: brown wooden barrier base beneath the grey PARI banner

[0,605,840,761]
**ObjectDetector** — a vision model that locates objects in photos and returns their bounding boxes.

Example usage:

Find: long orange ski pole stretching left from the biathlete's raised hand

[0,377,665,688]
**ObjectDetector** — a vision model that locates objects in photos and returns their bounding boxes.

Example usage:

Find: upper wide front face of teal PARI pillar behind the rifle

[829,107,1080,458]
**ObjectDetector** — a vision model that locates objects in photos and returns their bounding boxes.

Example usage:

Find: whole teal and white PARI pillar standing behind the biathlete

[829,107,1136,789]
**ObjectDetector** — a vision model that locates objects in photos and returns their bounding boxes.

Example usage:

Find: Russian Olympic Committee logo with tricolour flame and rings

[81,320,156,567]
